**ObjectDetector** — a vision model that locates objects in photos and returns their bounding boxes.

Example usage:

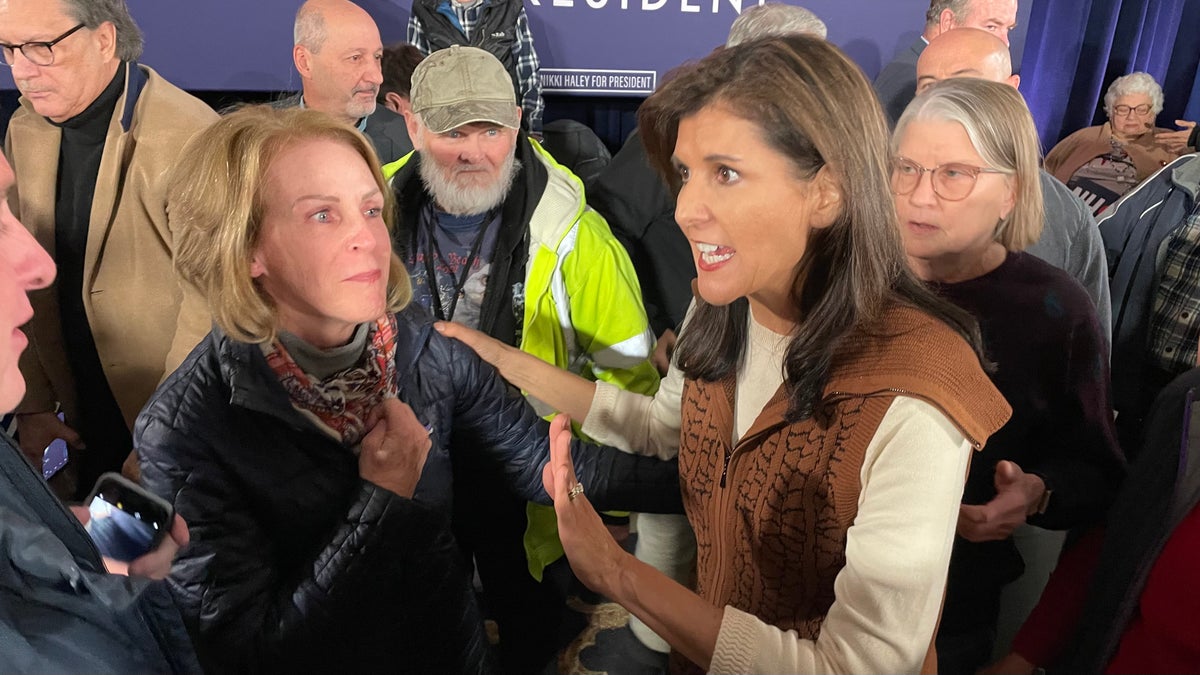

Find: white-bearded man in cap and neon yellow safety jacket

[384,46,659,673]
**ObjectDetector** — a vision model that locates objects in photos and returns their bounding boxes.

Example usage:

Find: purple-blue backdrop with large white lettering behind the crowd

[0,0,1028,94]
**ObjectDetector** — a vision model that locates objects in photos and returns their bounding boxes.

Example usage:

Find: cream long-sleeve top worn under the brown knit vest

[583,306,971,674]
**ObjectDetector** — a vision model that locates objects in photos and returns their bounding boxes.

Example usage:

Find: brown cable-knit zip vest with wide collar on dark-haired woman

[679,306,1010,667]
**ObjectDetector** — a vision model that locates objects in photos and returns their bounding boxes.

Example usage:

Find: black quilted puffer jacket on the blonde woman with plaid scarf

[134,310,682,674]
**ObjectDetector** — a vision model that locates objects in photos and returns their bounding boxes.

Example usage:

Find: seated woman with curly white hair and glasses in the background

[1045,72,1184,214]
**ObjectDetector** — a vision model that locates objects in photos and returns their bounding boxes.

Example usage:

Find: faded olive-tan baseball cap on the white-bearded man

[410,44,521,133]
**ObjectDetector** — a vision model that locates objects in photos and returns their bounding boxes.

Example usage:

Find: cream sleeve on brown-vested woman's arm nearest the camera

[710,396,971,674]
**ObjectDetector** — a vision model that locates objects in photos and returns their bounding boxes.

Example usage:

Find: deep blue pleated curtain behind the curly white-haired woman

[1021,0,1200,149]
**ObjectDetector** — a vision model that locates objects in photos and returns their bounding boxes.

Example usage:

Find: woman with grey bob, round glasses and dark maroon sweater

[892,79,1122,673]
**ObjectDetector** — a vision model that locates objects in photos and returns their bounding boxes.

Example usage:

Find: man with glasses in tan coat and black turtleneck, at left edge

[0,0,216,497]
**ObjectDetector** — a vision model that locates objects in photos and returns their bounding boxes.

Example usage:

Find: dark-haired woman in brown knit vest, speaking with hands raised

[440,36,1009,673]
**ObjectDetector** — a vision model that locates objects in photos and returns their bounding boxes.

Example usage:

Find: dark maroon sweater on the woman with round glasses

[931,253,1124,634]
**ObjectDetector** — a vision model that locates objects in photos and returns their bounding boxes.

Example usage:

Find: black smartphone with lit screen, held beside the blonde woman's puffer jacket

[85,473,175,562]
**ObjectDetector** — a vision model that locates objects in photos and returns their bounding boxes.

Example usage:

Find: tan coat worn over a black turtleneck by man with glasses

[5,64,217,429]
